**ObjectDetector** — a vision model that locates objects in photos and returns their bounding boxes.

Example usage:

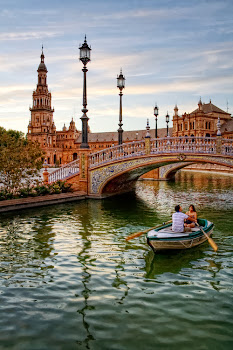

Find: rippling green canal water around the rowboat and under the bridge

[0,172,233,350]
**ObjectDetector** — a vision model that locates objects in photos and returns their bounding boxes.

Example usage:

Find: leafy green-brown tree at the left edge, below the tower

[0,127,44,188]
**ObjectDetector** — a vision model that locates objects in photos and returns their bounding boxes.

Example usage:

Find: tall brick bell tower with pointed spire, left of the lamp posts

[27,46,56,148]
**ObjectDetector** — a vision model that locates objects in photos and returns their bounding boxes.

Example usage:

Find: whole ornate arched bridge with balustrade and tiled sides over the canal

[48,136,233,198]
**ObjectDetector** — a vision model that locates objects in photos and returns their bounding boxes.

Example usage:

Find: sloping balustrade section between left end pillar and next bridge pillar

[89,140,146,168]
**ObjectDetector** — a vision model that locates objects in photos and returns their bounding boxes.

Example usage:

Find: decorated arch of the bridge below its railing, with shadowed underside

[89,153,233,197]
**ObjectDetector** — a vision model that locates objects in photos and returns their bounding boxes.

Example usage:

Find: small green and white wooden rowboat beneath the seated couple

[147,219,214,252]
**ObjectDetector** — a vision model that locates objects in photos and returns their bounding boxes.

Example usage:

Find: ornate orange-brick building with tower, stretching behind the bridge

[27,47,233,166]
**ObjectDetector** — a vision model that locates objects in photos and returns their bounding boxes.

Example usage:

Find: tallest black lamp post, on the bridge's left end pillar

[79,35,91,148]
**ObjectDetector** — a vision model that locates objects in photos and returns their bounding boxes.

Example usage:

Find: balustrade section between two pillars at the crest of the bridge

[151,137,217,154]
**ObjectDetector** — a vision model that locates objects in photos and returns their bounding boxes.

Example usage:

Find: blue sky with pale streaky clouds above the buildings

[0,0,233,133]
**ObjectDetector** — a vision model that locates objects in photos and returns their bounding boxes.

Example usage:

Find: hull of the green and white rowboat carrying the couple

[147,219,214,252]
